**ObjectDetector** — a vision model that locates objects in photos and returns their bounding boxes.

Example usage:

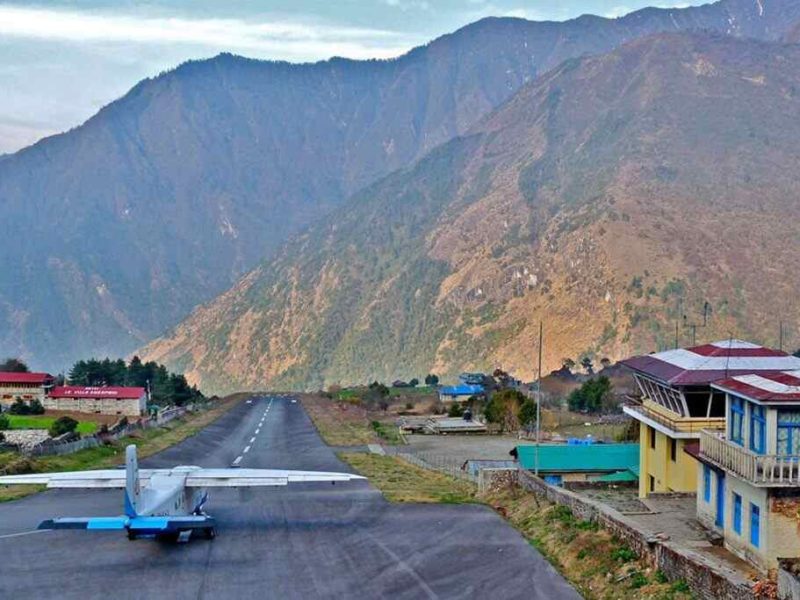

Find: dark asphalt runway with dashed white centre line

[0,397,579,600]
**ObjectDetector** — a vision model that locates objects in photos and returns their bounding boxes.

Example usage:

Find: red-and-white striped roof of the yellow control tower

[622,340,800,385]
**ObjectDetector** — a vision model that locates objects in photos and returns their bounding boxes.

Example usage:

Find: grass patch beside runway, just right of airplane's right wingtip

[339,452,476,504]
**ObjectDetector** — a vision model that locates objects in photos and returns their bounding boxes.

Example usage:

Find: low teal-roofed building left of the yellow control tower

[517,444,639,485]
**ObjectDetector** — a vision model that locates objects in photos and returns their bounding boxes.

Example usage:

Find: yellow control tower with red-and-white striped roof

[622,340,800,498]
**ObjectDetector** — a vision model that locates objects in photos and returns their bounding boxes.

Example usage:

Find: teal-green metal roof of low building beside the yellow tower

[517,444,639,473]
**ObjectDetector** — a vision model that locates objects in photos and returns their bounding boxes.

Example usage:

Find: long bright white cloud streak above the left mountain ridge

[0,5,414,59]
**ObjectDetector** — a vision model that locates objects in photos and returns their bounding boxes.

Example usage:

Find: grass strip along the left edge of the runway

[0,394,249,502]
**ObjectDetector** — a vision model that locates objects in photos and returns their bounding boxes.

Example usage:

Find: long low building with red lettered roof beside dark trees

[44,385,147,417]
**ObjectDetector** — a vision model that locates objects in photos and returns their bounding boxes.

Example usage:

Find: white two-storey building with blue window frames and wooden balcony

[697,369,800,571]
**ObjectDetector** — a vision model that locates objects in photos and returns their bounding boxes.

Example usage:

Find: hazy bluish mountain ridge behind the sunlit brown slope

[0,0,800,370]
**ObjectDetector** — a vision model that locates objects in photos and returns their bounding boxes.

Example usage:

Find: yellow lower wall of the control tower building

[639,424,698,498]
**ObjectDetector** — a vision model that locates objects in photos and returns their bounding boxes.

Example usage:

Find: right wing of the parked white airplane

[186,469,365,487]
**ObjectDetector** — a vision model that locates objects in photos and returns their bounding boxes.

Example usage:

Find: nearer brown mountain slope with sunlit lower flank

[145,33,800,390]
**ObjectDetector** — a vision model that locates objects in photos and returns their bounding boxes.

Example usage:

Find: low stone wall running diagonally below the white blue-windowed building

[518,470,756,600]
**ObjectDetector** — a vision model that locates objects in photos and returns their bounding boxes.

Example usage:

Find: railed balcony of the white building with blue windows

[700,429,800,487]
